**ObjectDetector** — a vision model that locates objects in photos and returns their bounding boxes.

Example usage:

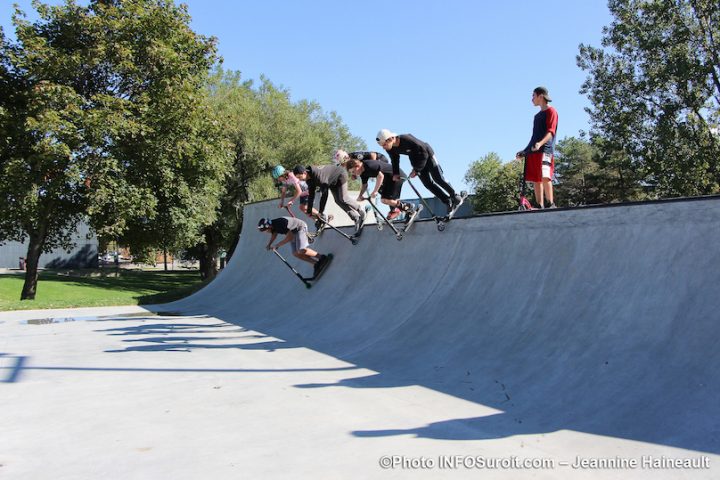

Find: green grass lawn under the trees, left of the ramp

[0,270,205,311]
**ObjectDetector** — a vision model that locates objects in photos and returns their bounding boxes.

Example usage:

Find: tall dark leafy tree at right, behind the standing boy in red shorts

[578,0,720,197]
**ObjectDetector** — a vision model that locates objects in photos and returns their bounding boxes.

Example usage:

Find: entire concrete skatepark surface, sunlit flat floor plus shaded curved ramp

[0,198,720,479]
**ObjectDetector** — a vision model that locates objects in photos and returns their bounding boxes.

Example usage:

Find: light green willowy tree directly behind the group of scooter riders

[191,68,365,278]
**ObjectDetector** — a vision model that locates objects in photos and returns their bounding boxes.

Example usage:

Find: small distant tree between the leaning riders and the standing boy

[465,152,522,213]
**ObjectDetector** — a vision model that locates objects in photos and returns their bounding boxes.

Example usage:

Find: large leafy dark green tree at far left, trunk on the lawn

[0,0,224,299]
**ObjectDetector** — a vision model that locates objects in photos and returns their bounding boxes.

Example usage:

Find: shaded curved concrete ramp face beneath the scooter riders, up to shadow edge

[167,197,720,454]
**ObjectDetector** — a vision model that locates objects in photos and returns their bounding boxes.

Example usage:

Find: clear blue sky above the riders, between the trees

[0,0,611,189]
